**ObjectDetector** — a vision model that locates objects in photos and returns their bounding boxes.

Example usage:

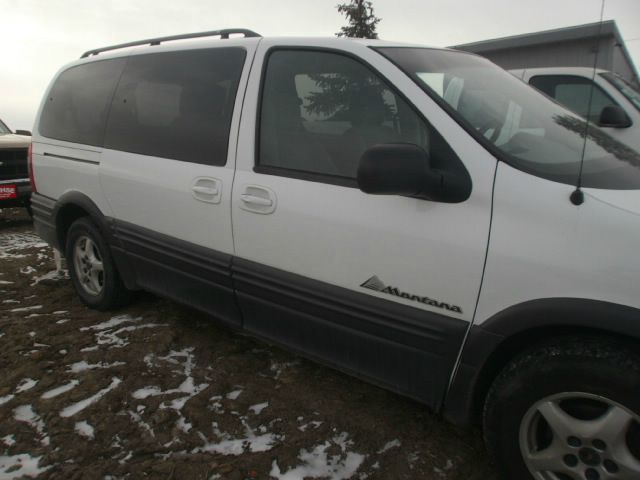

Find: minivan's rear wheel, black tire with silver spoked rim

[65,217,131,310]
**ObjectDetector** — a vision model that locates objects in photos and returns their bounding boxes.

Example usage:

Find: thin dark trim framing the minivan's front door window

[253,45,473,188]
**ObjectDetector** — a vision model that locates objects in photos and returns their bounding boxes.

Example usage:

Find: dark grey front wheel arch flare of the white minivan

[441,298,640,425]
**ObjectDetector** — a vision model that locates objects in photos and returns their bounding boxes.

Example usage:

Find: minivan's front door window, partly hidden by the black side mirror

[258,50,466,185]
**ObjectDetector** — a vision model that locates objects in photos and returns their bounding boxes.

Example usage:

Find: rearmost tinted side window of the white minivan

[39,59,125,146]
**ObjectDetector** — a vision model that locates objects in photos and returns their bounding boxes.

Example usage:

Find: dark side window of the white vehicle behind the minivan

[529,75,616,123]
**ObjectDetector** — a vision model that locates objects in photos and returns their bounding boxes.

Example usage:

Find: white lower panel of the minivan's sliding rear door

[100,150,233,253]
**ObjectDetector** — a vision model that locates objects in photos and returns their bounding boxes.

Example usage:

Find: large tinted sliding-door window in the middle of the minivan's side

[105,48,246,165]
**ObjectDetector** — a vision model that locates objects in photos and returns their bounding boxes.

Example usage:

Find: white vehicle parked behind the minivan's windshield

[510,67,640,151]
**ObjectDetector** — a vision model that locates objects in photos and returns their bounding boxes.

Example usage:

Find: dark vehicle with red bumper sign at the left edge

[0,120,31,215]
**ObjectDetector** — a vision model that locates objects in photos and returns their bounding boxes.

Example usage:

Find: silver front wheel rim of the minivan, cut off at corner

[520,392,640,480]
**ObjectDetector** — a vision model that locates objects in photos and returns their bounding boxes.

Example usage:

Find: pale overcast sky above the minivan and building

[0,0,640,130]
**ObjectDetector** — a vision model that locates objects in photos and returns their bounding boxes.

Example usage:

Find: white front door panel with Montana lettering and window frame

[232,40,496,321]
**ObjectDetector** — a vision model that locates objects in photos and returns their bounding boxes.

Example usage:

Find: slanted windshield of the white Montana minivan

[377,47,640,189]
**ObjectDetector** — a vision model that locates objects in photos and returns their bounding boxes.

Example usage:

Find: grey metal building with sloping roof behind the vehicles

[450,20,640,85]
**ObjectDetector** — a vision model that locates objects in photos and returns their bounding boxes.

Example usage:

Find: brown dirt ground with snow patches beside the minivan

[0,209,494,480]
